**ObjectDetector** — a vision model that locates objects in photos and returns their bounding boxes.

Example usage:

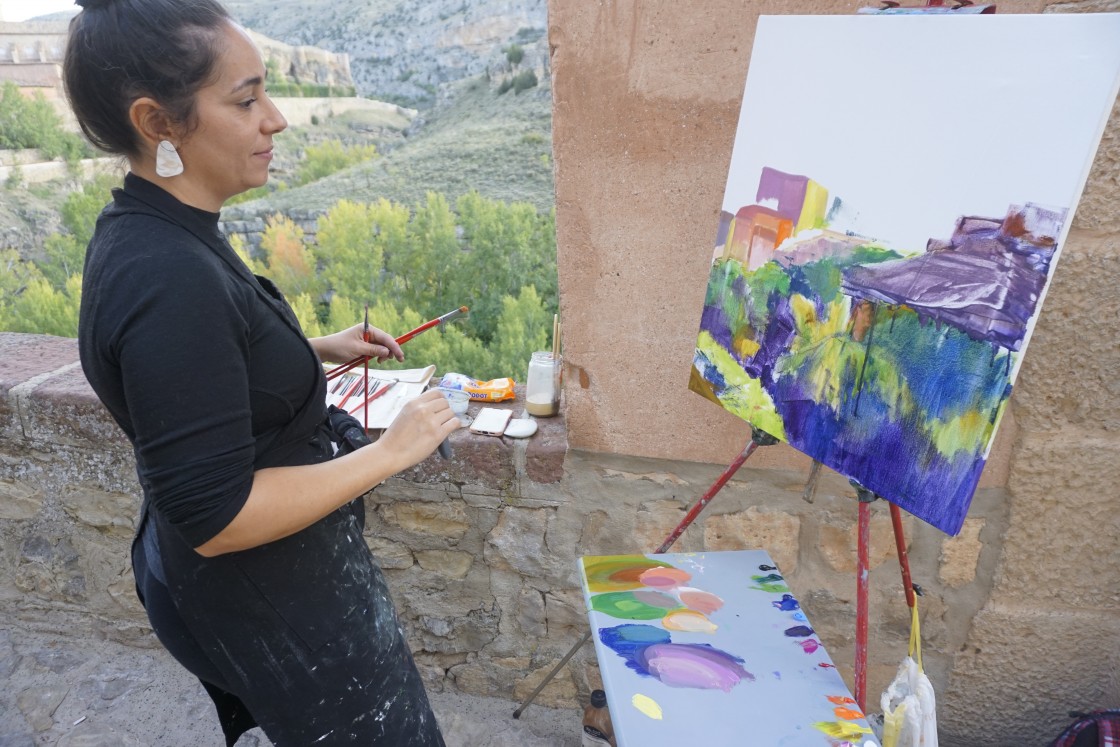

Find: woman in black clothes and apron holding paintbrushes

[64,0,458,746]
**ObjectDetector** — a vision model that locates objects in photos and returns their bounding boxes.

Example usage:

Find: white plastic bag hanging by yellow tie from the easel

[880,600,937,747]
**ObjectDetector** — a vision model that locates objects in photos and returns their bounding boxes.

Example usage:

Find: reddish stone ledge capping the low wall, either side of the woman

[0,333,568,492]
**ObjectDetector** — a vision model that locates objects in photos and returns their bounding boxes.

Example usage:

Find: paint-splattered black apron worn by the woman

[123,190,444,747]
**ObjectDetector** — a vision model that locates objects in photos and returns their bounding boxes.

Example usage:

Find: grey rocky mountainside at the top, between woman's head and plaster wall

[225,0,548,105]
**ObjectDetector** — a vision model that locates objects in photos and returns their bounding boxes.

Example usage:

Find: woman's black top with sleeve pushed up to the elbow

[78,174,325,547]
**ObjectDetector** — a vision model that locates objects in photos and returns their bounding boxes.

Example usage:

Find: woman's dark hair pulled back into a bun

[63,0,230,156]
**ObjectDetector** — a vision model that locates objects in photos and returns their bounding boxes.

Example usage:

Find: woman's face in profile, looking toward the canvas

[176,24,288,213]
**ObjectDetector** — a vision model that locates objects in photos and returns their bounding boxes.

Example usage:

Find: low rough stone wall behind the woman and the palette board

[0,333,1057,745]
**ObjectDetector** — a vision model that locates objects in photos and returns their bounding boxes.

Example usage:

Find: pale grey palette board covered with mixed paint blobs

[580,550,878,747]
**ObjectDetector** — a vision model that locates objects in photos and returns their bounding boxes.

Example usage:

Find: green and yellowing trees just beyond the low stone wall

[0,183,557,381]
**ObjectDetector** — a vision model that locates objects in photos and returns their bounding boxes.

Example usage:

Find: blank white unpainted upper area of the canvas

[724,13,1120,251]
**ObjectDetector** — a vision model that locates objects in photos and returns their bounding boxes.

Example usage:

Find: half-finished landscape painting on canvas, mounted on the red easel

[689,13,1120,534]
